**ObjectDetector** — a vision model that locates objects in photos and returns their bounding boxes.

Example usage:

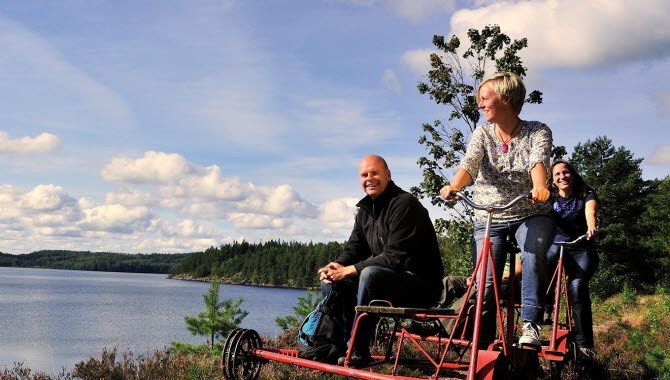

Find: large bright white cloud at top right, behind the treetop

[451,0,670,67]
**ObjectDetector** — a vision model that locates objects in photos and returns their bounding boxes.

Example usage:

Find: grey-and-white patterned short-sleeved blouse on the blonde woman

[460,121,552,223]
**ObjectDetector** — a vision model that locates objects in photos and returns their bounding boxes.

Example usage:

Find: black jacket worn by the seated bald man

[336,181,444,287]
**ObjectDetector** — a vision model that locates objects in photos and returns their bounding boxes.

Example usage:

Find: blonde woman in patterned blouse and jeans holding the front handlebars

[440,72,555,349]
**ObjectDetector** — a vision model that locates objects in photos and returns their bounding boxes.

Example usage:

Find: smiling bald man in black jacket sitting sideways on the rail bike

[318,155,443,366]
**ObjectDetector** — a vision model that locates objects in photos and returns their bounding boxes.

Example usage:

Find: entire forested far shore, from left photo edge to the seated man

[0,240,344,288]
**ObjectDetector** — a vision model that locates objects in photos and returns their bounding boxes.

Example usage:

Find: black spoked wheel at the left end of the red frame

[223,329,263,380]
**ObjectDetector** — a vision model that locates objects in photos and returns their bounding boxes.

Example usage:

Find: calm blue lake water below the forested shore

[0,267,306,373]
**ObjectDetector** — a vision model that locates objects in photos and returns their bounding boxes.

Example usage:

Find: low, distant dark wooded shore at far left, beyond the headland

[0,250,188,274]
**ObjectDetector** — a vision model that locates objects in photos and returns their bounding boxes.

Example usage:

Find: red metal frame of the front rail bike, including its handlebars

[224,193,540,380]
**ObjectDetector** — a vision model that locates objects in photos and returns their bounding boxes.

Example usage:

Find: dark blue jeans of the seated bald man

[321,266,442,350]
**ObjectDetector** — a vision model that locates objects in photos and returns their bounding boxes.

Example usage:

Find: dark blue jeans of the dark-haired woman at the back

[547,245,600,348]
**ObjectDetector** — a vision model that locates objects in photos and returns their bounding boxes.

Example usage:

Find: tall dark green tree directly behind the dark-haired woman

[570,136,653,296]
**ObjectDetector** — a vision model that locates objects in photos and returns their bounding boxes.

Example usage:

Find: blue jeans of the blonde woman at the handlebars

[473,215,556,345]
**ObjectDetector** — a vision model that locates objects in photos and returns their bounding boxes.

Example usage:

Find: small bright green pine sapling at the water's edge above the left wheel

[184,282,249,348]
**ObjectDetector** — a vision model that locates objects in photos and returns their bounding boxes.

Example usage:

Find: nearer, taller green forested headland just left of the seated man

[171,240,344,288]
